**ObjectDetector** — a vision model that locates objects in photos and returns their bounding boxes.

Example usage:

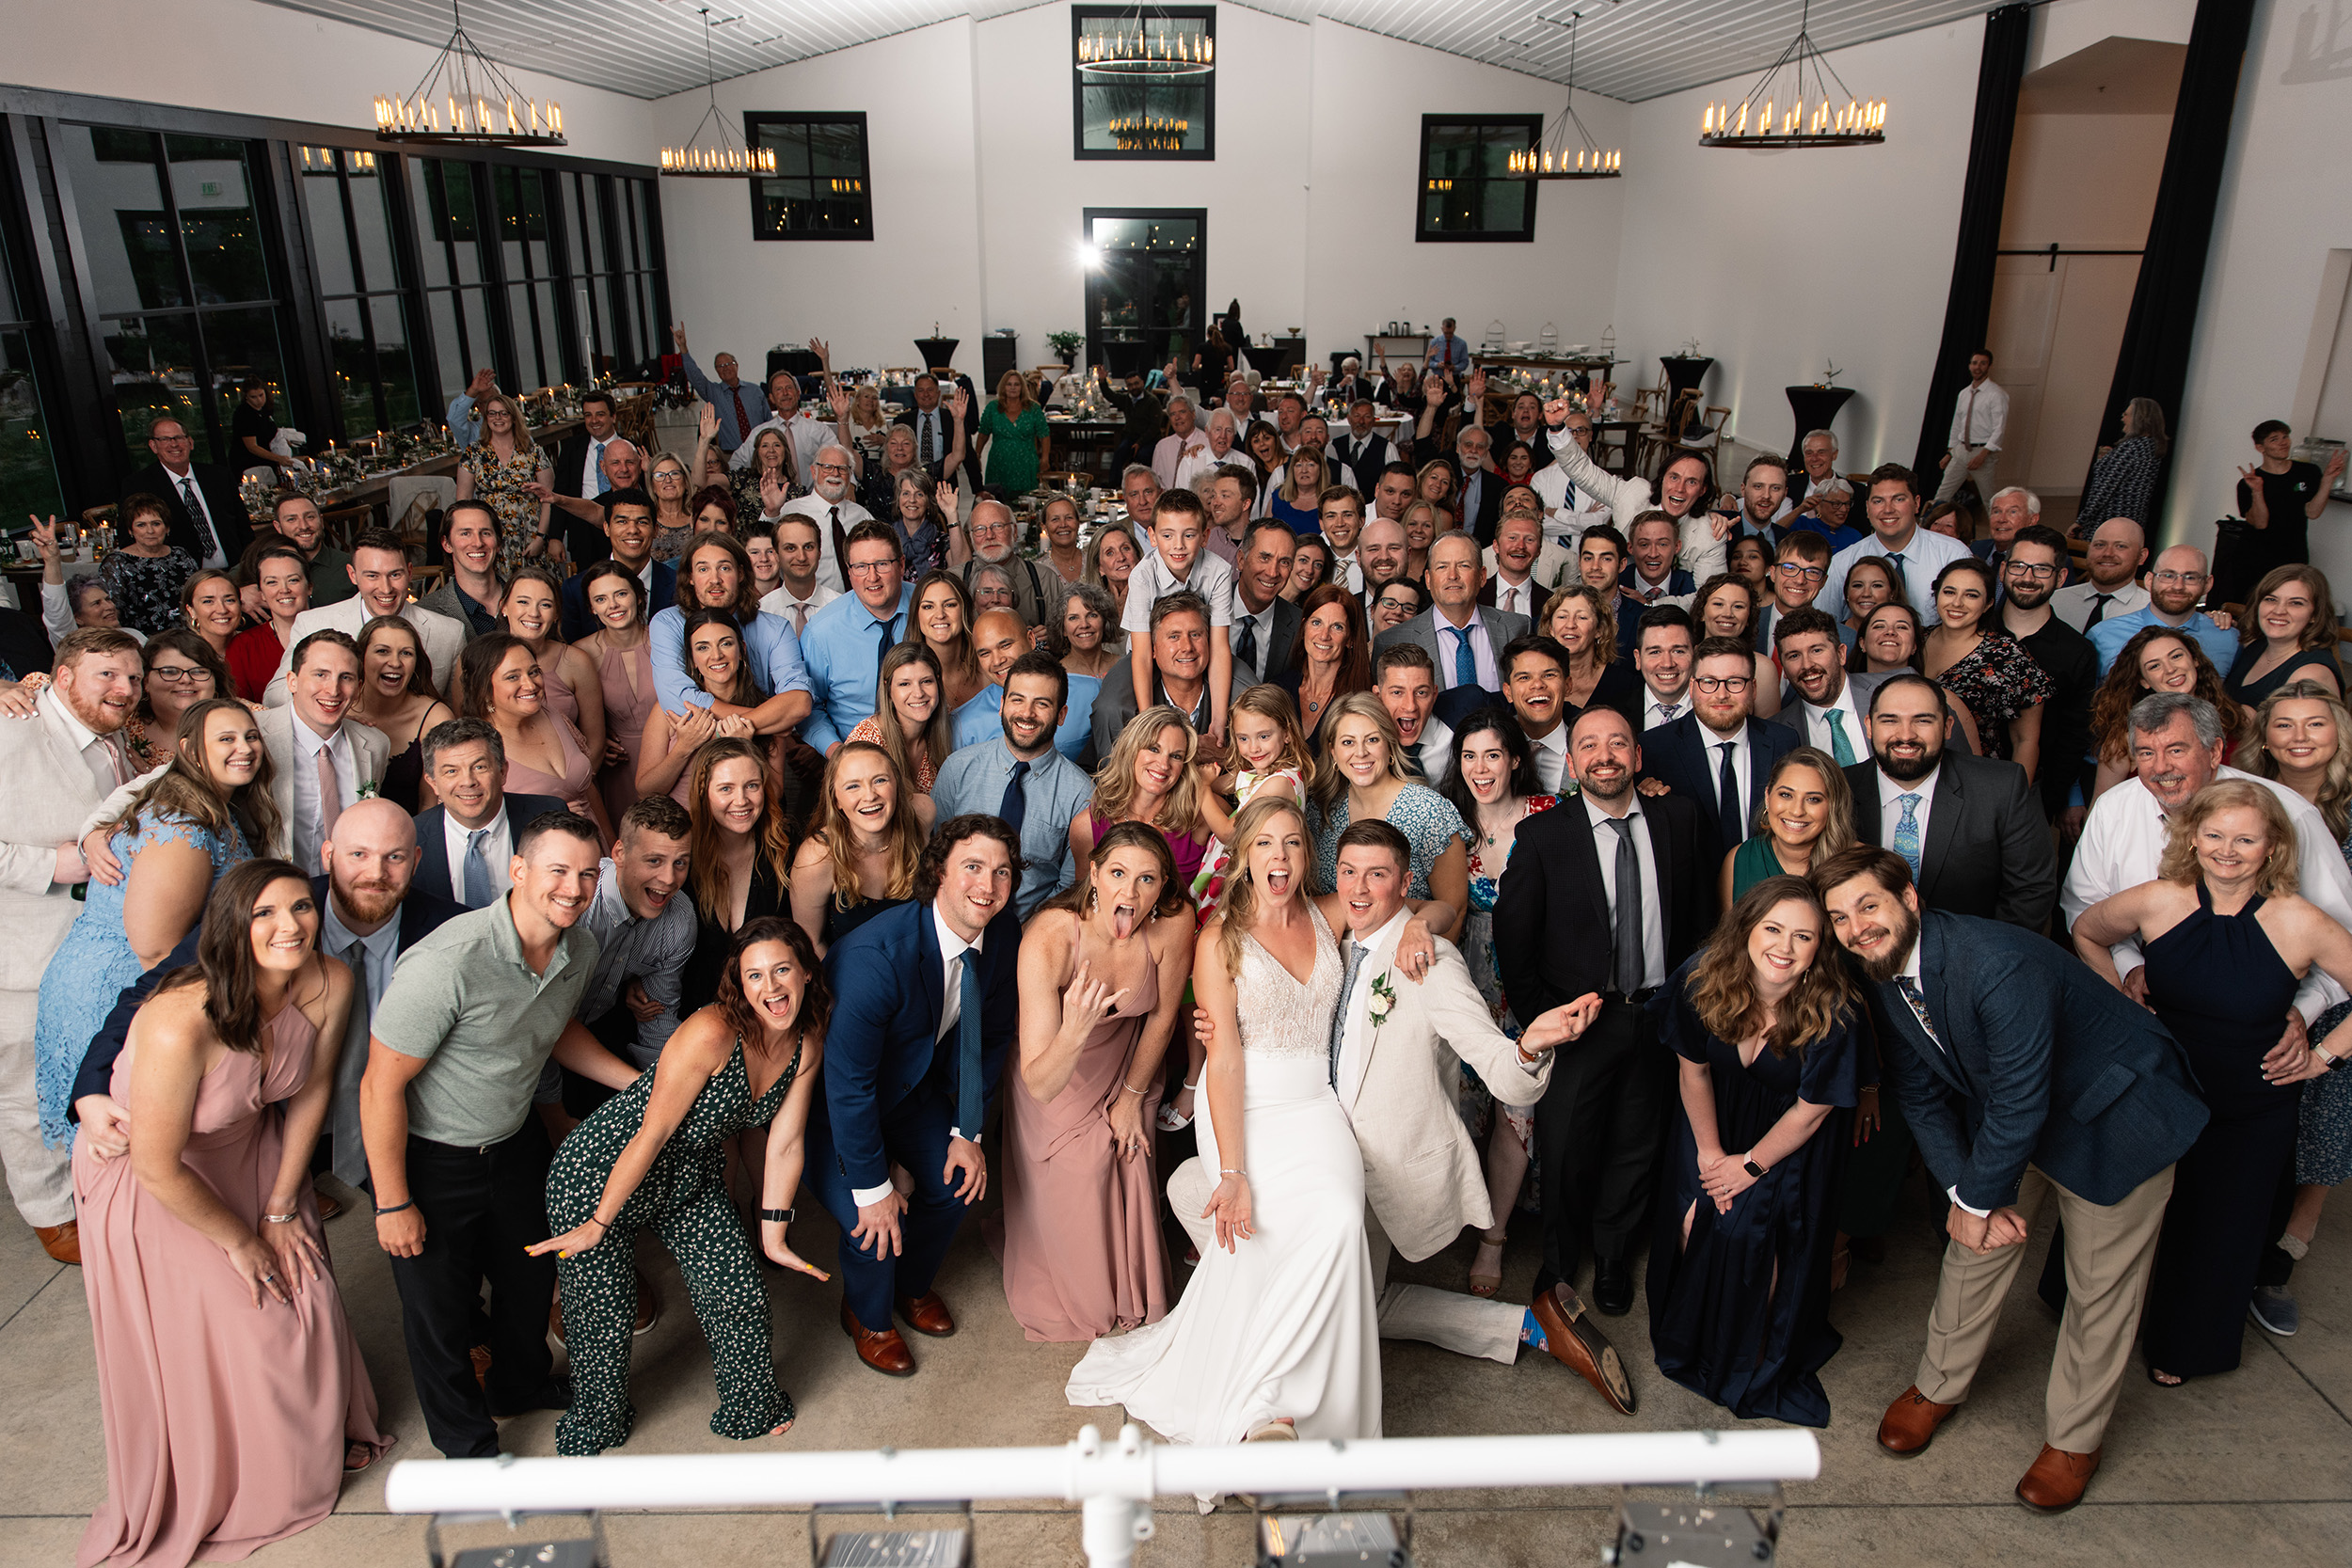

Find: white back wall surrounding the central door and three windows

[657,5,1632,373]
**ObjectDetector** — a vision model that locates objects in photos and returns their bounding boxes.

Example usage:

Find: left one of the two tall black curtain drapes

[1913,5,2035,489]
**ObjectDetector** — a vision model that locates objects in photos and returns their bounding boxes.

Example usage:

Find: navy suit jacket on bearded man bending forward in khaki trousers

[1875,910,2206,1209]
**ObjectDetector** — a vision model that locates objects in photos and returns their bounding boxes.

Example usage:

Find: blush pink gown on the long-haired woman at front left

[73,1004,393,1568]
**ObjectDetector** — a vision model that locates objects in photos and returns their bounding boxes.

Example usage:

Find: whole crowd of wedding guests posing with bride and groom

[0,338,2352,1563]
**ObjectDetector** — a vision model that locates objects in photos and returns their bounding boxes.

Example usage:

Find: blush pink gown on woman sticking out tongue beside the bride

[1000,921,1169,1342]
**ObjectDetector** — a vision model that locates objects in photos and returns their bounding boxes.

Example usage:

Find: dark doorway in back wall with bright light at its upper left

[1087,207,1214,376]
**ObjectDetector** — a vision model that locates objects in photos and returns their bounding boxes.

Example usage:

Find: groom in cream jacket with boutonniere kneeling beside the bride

[1169,818,1623,1397]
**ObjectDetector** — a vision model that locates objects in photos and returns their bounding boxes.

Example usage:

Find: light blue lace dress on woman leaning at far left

[33,814,254,1148]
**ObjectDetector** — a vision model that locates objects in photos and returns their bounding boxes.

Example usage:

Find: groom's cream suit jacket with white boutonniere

[1341,938,1552,1262]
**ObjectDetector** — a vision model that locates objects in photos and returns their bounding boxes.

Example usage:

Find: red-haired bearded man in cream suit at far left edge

[0,626,141,1262]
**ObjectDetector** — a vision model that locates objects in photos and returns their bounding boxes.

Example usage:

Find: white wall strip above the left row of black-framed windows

[0,0,659,162]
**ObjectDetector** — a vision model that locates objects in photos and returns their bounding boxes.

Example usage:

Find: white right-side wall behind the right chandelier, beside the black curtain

[1616,16,1985,470]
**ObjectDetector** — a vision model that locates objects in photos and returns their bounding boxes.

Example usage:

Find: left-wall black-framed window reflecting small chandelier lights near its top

[296,146,423,449]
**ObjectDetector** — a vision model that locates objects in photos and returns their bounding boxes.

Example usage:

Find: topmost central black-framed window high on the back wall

[1071,5,1216,160]
